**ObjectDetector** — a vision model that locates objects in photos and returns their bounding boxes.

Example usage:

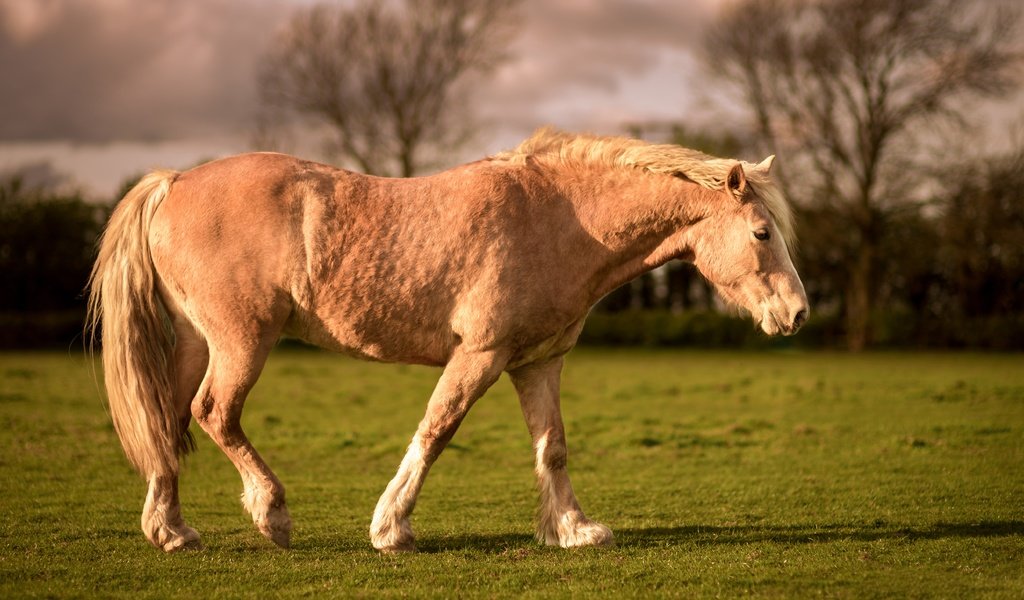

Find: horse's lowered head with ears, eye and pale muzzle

[690,157,808,335]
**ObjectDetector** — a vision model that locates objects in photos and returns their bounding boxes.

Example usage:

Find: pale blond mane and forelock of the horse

[492,127,796,248]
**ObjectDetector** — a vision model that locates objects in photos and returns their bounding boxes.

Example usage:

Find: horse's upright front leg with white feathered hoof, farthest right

[509,357,612,548]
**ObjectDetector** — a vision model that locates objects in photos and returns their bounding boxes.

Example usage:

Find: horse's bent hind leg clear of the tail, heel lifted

[191,330,292,548]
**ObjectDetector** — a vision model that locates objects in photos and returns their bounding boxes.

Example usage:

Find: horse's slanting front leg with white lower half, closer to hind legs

[370,351,507,552]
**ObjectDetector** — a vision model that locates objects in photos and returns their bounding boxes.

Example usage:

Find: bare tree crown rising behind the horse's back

[259,0,519,176]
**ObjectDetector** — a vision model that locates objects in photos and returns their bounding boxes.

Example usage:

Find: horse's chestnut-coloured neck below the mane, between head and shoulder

[548,163,708,301]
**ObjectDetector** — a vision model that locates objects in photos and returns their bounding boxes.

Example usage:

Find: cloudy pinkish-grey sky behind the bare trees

[0,0,1019,200]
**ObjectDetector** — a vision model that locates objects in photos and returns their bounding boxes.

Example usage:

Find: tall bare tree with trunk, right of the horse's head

[706,0,1021,349]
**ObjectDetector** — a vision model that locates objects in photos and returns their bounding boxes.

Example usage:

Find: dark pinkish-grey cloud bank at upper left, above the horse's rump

[0,0,287,142]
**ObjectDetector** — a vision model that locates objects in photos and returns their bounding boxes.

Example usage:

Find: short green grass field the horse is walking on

[0,349,1024,598]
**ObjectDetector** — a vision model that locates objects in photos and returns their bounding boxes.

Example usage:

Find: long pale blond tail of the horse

[86,171,191,477]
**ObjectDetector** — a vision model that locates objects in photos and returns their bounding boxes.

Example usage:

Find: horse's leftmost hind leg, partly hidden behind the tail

[142,320,209,552]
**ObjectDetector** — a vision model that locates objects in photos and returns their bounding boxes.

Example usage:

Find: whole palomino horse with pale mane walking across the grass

[88,129,808,552]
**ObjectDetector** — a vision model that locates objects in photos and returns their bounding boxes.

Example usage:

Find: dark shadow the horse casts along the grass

[403,521,1024,553]
